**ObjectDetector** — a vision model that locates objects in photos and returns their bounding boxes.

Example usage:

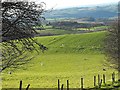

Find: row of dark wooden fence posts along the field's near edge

[19,72,120,90]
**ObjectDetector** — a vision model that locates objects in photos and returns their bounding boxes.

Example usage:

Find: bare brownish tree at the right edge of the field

[104,20,120,79]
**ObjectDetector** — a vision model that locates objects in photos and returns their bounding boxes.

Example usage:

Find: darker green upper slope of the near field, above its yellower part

[38,32,105,53]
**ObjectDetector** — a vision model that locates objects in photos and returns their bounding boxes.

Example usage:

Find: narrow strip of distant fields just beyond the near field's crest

[36,26,108,35]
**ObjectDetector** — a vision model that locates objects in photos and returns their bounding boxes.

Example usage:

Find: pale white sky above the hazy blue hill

[30,0,120,9]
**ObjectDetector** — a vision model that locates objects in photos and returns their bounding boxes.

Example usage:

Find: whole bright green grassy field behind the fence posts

[2,32,117,88]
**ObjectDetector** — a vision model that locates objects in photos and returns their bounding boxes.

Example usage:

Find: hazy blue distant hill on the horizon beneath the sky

[44,4,118,19]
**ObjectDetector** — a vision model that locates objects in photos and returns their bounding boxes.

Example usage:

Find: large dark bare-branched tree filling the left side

[0,1,47,71]
